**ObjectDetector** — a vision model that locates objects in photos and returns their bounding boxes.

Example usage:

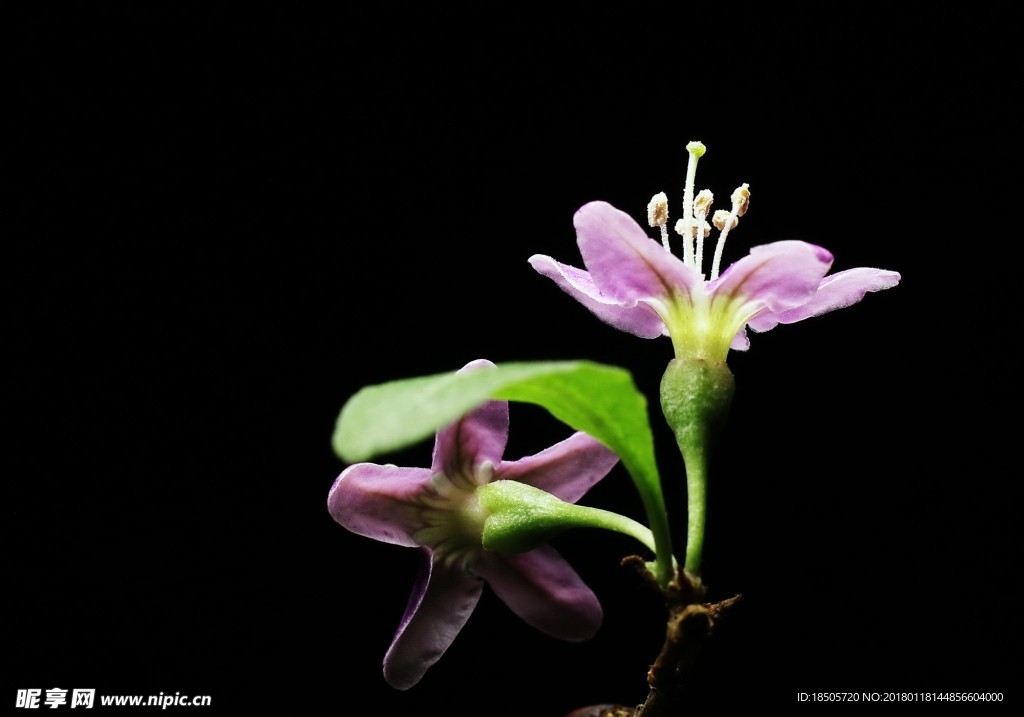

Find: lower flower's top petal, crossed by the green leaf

[431,359,509,476]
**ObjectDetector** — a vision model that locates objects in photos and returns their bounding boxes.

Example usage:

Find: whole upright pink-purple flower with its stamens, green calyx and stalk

[529,142,900,575]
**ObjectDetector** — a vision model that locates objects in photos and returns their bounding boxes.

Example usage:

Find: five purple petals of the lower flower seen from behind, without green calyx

[328,361,618,689]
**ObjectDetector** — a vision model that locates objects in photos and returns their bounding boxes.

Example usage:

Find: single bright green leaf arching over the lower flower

[333,361,672,585]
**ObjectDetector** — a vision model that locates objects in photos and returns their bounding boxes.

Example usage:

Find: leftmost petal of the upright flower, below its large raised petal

[529,254,665,339]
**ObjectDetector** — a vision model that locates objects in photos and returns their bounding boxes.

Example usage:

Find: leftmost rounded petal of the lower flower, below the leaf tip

[327,463,431,547]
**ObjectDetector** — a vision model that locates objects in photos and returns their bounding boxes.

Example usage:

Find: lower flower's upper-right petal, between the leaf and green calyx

[495,431,618,503]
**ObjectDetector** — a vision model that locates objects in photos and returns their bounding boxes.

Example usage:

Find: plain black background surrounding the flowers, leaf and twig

[6,2,1022,717]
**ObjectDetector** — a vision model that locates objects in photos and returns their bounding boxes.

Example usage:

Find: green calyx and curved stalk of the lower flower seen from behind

[476,480,654,553]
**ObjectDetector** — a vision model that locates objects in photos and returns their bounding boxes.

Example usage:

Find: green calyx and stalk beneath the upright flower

[662,359,736,576]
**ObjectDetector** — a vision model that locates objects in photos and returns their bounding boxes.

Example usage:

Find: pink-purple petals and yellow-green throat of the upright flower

[529,198,900,362]
